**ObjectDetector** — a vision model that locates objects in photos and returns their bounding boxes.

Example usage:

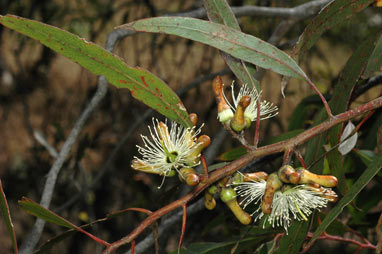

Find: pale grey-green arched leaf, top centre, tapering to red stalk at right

[118,17,307,79]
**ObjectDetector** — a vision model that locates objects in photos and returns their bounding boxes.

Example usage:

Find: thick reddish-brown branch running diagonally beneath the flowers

[104,97,382,254]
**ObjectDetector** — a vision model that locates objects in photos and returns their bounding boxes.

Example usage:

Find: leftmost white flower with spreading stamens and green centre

[131,118,200,179]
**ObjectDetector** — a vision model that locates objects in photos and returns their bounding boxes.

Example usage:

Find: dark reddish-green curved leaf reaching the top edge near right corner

[294,0,374,60]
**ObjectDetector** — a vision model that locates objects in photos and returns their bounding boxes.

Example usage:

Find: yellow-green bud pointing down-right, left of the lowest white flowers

[220,188,252,225]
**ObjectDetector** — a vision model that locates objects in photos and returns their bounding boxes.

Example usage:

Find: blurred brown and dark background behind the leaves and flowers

[0,0,382,253]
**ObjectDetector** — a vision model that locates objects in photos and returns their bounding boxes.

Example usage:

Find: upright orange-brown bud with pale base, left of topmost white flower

[212,76,233,123]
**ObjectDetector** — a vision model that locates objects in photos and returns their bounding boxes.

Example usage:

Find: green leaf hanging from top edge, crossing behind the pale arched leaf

[204,0,260,91]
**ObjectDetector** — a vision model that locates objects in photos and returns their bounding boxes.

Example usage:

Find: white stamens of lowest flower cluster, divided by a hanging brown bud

[231,180,337,234]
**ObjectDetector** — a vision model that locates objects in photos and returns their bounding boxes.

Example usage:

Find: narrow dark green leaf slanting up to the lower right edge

[308,156,382,247]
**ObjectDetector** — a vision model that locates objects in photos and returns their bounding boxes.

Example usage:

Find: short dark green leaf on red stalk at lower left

[19,197,77,229]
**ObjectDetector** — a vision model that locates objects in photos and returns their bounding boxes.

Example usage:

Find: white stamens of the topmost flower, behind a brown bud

[226,83,278,122]
